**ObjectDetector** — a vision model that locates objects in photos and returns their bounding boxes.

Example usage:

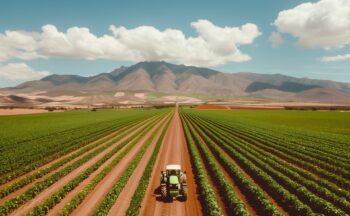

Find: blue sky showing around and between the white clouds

[0,0,350,87]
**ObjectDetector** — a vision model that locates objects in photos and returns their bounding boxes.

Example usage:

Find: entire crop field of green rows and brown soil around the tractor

[0,108,350,216]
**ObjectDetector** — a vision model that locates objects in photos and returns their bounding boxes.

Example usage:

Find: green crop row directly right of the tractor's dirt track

[182,115,223,216]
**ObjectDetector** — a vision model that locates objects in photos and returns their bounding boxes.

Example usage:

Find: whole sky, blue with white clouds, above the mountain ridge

[0,0,350,87]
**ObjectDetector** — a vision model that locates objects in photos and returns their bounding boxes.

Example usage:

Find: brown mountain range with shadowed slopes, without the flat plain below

[2,61,350,103]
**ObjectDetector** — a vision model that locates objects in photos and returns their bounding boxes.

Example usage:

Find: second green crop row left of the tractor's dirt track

[93,113,171,216]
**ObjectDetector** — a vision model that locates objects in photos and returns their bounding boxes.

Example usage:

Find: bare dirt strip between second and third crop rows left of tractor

[72,114,165,216]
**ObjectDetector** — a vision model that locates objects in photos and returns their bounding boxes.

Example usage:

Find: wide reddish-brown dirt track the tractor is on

[140,111,202,216]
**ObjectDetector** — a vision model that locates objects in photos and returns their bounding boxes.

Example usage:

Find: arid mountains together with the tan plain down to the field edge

[0,61,350,108]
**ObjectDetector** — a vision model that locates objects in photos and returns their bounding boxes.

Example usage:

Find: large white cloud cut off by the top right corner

[274,0,350,49]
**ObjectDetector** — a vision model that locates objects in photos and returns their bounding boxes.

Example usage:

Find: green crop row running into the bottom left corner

[0,112,164,215]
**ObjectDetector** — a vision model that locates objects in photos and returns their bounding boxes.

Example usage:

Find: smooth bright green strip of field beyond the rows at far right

[190,110,350,136]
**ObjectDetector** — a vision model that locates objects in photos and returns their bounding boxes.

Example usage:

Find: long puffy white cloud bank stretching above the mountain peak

[0,20,261,66]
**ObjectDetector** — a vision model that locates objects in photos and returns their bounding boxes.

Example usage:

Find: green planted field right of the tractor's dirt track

[182,109,350,215]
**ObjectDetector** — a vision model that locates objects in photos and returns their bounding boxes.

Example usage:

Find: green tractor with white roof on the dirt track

[160,164,187,200]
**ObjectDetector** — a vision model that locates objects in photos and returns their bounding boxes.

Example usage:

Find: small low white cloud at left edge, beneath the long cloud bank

[0,63,49,80]
